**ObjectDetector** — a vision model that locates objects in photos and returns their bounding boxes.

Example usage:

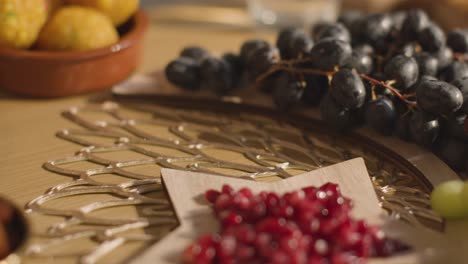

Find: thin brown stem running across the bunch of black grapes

[255,62,417,107]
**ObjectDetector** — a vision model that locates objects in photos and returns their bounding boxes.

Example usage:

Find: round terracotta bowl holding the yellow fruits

[0,11,148,98]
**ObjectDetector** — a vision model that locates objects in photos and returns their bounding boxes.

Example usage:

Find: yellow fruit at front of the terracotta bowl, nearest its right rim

[37,6,119,51]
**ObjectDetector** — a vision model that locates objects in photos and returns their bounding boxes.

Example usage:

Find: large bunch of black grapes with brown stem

[166,9,468,175]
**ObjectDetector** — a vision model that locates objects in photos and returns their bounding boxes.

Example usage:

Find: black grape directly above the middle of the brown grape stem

[310,38,352,71]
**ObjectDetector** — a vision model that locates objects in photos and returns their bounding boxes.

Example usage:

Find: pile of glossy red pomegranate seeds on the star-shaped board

[182,183,408,264]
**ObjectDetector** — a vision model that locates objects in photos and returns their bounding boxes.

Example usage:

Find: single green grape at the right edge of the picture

[431,180,468,220]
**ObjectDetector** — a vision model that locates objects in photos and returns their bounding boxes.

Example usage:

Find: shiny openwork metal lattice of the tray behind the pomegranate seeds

[26,102,441,263]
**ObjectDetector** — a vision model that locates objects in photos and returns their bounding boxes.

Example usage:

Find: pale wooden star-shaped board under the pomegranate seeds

[132,158,424,264]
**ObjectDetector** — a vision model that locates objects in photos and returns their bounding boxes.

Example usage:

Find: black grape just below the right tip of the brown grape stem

[409,111,440,147]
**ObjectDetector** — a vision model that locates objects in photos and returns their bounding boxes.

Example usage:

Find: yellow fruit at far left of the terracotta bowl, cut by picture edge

[0,0,48,49]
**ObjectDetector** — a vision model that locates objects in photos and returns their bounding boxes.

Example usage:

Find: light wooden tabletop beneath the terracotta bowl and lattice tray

[0,7,468,263]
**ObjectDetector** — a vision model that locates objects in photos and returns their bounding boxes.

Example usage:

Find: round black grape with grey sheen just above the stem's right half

[384,55,419,89]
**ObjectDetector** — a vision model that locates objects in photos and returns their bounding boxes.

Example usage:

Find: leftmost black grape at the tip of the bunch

[165,57,201,90]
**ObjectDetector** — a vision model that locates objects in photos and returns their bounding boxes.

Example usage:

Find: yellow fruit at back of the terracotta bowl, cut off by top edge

[65,0,140,26]
